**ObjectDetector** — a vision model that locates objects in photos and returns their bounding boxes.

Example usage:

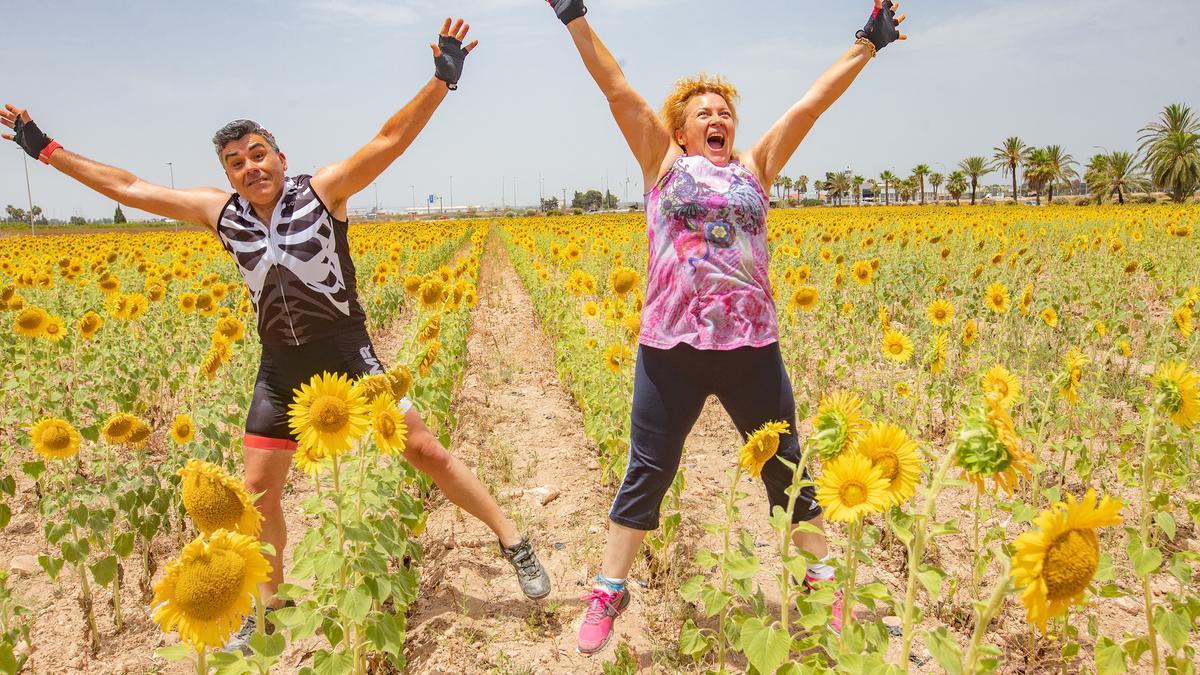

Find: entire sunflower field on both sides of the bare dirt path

[0,205,1200,674]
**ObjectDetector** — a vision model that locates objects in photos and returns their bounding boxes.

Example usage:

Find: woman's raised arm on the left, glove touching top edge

[550,0,672,183]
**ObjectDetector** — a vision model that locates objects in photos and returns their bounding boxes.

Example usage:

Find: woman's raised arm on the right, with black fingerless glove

[746,0,908,185]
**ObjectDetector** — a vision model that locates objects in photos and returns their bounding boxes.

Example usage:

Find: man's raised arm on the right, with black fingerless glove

[312,19,479,215]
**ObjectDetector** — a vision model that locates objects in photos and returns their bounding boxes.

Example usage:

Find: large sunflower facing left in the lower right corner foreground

[1013,490,1123,632]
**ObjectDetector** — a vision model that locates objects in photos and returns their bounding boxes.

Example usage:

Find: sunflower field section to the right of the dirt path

[504,207,1200,673]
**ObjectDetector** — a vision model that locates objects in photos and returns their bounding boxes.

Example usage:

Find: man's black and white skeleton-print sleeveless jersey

[217,175,366,345]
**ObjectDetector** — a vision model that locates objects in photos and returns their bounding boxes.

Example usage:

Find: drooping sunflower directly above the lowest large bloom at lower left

[179,459,263,537]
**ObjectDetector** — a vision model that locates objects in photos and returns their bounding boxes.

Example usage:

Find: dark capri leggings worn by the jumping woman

[608,342,821,531]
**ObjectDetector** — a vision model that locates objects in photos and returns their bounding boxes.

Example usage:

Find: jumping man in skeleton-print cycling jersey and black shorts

[0,19,550,649]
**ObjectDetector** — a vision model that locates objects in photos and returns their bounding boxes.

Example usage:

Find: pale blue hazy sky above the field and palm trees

[0,0,1200,219]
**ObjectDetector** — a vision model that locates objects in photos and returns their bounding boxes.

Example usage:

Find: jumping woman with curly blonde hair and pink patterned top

[547,0,905,653]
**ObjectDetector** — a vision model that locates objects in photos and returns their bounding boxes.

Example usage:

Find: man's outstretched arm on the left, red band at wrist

[0,103,229,229]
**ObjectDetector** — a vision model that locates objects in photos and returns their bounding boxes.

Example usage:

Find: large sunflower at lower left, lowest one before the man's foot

[150,530,271,650]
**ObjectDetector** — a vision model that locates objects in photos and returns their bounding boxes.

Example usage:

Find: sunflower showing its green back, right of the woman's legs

[954,400,1033,495]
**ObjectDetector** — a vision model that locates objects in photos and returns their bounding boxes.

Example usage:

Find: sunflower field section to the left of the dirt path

[0,222,486,673]
